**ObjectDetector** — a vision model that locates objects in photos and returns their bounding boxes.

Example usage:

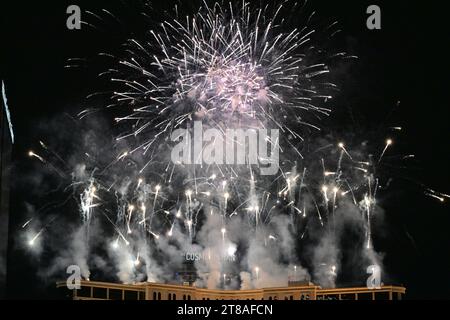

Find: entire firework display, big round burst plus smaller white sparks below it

[24,1,448,287]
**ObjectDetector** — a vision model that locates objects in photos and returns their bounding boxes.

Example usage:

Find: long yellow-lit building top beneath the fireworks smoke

[56,281,406,300]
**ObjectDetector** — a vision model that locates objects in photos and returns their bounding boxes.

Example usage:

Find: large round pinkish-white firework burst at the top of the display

[80,1,352,159]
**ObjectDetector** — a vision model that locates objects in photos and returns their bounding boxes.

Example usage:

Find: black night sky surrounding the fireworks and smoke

[0,0,450,299]
